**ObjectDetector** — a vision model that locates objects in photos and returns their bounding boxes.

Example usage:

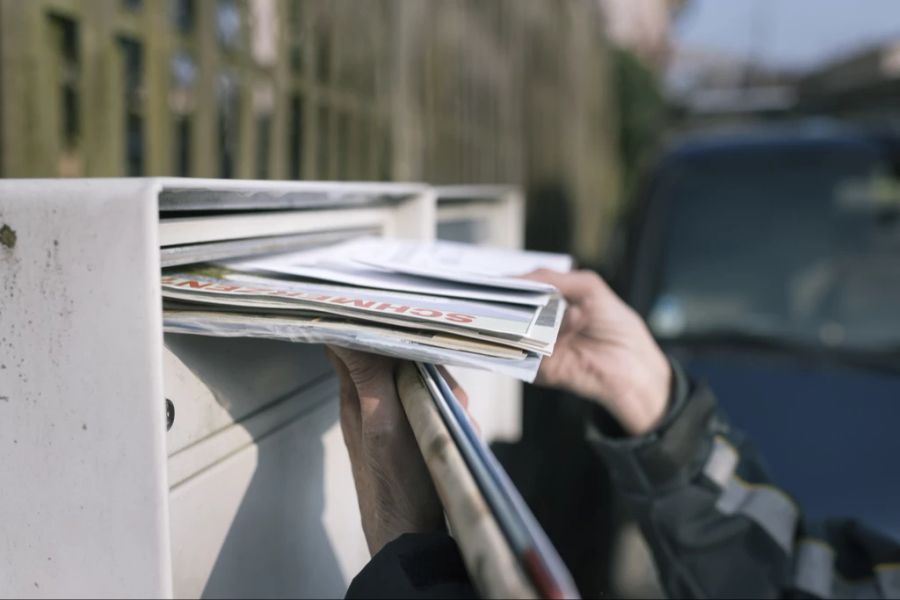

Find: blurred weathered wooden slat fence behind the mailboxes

[0,0,619,259]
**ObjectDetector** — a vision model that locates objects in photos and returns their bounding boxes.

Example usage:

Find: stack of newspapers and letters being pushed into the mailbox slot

[162,238,571,381]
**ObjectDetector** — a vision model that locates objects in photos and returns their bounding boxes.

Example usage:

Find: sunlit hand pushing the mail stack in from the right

[526,269,672,435]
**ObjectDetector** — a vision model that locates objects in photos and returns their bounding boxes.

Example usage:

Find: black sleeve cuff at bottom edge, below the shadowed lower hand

[347,533,478,598]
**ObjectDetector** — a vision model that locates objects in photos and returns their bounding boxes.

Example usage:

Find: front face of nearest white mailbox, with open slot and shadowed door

[159,180,434,597]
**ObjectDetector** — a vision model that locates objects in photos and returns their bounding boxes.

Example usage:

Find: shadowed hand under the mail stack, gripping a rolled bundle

[327,347,445,556]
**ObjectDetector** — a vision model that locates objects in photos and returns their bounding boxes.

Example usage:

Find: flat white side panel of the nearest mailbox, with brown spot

[0,179,172,598]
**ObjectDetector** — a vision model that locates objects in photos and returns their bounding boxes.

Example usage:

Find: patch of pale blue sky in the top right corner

[672,0,900,70]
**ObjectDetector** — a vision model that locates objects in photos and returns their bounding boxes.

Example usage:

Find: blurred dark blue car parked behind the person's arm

[624,123,900,539]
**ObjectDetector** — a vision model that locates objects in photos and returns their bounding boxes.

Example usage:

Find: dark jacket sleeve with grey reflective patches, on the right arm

[588,365,900,598]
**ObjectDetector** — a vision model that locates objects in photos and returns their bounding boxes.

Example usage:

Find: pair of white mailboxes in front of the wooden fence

[0,178,522,597]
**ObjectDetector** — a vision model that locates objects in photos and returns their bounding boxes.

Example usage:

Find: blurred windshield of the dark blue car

[648,138,900,351]
